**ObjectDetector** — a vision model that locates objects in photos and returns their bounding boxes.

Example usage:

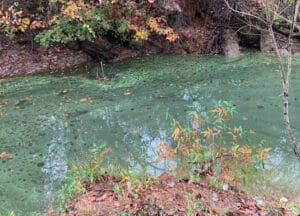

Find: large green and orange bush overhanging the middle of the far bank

[33,0,178,46]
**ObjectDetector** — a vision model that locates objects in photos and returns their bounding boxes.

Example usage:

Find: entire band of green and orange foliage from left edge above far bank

[0,0,178,46]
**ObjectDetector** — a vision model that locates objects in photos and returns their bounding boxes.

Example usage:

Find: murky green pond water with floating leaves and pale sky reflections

[0,54,300,215]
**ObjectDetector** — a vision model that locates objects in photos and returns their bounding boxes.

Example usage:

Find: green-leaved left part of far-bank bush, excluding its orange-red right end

[35,2,129,46]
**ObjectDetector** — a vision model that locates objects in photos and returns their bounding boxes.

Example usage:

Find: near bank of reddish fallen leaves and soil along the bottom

[62,173,295,216]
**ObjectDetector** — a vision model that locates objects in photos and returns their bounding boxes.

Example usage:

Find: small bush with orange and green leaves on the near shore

[157,102,271,185]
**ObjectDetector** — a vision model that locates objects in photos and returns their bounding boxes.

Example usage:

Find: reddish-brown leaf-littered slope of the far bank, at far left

[0,38,91,78]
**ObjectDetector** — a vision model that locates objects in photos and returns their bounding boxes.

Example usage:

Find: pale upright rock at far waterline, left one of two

[222,30,241,58]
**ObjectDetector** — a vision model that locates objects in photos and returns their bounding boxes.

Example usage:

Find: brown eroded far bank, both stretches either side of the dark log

[0,19,219,79]
